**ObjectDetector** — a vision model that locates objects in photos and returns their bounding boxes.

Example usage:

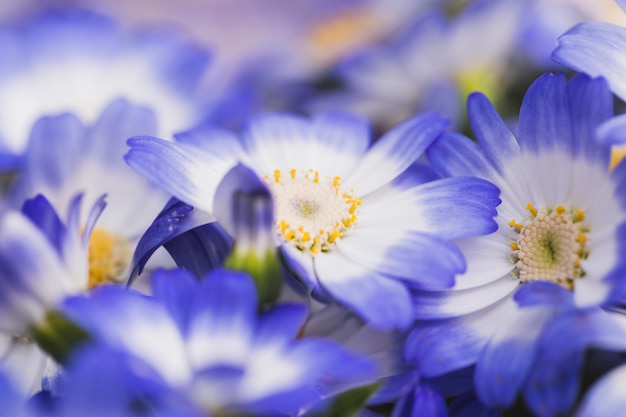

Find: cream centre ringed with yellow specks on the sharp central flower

[265,169,361,255]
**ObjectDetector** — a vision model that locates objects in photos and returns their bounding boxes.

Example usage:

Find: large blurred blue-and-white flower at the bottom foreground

[59,270,375,415]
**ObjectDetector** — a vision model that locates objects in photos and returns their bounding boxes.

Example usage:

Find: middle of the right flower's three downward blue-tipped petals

[474,307,554,408]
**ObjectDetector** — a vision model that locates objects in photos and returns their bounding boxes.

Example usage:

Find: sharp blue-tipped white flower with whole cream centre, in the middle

[126,109,499,329]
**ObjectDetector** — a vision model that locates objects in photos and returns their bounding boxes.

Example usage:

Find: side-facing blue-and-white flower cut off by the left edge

[0,195,104,394]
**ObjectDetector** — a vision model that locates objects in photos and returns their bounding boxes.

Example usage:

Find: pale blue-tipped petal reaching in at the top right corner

[552,22,626,99]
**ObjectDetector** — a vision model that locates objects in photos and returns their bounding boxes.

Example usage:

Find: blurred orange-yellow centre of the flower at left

[88,228,131,288]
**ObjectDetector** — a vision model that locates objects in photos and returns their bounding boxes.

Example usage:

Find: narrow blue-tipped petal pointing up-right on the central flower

[345,113,448,196]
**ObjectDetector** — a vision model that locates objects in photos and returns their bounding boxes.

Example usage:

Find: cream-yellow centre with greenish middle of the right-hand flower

[509,203,589,290]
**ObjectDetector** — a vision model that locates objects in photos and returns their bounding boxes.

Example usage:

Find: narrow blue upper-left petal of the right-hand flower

[467,93,519,172]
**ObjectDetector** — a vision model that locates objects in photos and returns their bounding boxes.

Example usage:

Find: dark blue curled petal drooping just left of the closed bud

[130,198,216,282]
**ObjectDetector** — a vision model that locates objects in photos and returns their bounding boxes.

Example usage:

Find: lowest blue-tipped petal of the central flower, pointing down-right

[314,251,413,330]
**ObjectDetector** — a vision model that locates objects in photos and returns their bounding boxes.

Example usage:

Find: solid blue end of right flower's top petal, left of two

[518,74,574,153]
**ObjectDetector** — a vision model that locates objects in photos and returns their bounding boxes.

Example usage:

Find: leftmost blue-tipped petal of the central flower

[124,136,221,211]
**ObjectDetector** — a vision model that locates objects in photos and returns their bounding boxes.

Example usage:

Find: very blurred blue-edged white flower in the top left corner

[0,10,208,169]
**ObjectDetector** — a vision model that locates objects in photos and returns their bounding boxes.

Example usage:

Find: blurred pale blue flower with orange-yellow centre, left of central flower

[9,100,174,287]
